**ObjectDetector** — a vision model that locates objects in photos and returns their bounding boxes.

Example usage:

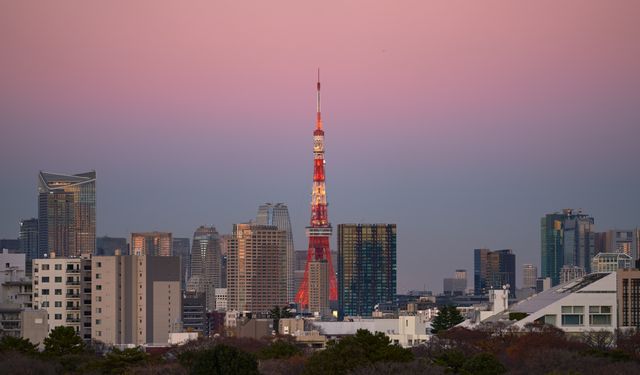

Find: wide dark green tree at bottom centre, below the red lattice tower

[305,329,414,375]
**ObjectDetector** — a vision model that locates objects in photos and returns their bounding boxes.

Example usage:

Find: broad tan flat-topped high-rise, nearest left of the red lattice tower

[227,224,287,315]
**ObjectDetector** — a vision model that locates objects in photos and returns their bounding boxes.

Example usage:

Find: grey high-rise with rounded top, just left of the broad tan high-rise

[191,226,222,311]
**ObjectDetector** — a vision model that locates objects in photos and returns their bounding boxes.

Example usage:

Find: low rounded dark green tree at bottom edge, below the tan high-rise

[179,344,259,375]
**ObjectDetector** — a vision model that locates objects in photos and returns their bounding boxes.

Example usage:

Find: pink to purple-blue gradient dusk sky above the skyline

[0,1,640,291]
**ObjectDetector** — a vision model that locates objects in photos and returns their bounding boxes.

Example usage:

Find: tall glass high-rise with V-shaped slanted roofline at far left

[38,171,96,258]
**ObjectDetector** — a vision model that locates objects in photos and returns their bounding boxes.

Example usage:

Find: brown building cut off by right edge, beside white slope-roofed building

[616,269,640,329]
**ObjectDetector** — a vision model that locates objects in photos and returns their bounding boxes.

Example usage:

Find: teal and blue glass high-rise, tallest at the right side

[540,209,602,285]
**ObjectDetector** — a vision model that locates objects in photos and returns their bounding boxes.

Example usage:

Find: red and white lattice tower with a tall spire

[296,69,338,308]
